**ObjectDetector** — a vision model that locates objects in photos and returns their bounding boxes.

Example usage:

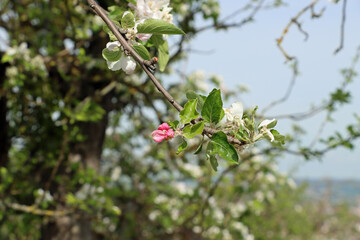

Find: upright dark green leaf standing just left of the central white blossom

[201,89,224,124]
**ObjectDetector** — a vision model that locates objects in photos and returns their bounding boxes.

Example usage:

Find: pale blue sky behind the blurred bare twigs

[187,0,360,178]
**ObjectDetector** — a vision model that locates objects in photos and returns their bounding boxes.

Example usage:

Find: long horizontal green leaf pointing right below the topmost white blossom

[137,18,185,35]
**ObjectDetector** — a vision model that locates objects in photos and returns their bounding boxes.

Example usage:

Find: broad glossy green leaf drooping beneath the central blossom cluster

[211,131,239,163]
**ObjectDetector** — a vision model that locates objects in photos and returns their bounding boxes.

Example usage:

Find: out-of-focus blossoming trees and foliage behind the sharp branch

[0,0,360,240]
